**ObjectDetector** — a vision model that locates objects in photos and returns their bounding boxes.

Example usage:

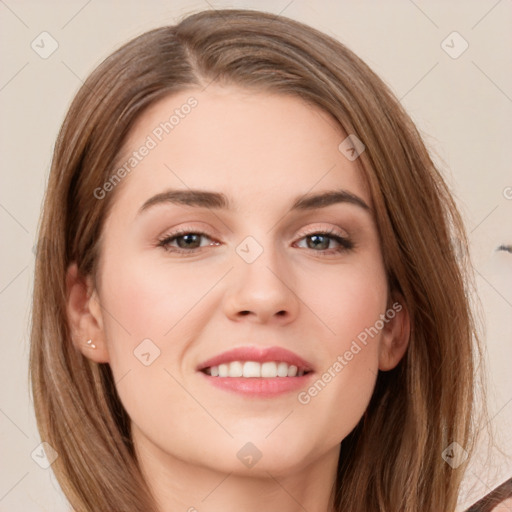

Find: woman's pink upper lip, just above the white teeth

[197,346,313,371]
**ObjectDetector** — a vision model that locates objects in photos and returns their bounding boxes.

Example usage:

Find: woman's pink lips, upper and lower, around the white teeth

[197,347,313,398]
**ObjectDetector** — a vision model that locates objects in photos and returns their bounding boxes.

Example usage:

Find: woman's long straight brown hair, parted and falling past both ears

[30,9,485,512]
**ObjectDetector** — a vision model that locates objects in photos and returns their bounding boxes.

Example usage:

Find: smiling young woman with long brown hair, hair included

[31,10,500,512]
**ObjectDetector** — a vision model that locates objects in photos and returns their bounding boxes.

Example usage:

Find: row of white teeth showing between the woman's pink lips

[205,361,305,378]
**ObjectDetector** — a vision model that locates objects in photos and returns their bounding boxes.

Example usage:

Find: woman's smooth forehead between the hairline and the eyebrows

[109,85,371,218]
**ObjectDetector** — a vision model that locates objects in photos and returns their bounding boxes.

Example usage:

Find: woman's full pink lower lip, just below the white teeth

[199,372,313,398]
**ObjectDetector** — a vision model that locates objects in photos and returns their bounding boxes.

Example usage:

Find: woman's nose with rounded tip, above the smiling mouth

[224,241,300,324]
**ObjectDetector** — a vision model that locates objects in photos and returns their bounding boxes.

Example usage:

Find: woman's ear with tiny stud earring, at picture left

[66,263,109,363]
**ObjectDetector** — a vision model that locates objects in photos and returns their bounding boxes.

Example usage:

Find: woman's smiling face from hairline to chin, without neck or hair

[75,85,406,475]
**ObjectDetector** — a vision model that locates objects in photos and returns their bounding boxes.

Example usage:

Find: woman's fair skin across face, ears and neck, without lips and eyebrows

[68,84,409,512]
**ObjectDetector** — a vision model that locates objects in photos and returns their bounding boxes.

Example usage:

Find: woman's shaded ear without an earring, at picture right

[379,295,411,371]
